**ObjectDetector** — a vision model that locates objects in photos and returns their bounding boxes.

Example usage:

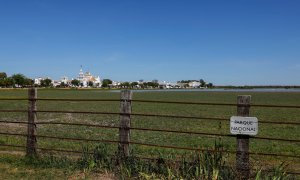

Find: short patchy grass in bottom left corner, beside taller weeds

[0,154,117,180]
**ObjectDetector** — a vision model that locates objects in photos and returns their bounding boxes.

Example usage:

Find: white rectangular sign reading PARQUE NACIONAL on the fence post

[230,116,258,136]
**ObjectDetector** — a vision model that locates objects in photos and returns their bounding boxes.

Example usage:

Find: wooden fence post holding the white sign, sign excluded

[236,95,251,179]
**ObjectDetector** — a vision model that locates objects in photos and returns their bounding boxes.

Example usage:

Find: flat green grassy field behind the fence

[0,89,300,174]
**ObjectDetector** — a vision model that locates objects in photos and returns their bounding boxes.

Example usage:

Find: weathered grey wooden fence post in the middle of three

[119,90,132,157]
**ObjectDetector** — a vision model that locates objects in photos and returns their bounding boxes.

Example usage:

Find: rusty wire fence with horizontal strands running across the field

[0,90,300,177]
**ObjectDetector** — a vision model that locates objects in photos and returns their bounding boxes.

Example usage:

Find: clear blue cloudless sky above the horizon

[0,0,300,85]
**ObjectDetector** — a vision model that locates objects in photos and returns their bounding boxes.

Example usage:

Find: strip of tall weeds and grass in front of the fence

[0,141,296,180]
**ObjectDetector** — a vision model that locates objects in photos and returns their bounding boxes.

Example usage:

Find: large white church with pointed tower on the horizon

[77,67,102,87]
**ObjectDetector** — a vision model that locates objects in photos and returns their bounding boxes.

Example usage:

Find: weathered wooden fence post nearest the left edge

[26,88,37,156]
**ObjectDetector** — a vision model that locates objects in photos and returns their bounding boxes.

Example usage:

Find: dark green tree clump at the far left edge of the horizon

[0,72,34,88]
